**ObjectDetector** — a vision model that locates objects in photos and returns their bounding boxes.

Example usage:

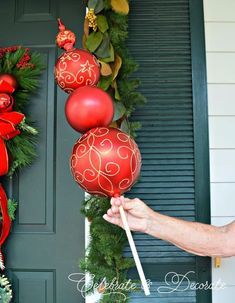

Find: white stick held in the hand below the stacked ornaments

[119,205,150,296]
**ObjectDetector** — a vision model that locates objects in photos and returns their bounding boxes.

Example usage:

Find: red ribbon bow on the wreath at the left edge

[0,112,24,176]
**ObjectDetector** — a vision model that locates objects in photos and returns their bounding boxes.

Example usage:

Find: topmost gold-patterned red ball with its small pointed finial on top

[54,19,100,93]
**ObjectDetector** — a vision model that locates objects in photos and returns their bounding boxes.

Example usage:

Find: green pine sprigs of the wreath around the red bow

[0,47,44,177]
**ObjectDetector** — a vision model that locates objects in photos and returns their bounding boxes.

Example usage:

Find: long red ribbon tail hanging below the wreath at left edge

[0,184,11,270]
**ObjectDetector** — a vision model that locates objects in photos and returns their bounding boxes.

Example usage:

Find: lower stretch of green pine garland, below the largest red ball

[80,196,134,303]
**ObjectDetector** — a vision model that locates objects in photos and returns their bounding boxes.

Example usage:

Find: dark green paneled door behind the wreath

[0,0,85,303]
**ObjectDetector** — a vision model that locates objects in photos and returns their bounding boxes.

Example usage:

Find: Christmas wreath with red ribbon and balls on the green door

[0,46,43,302]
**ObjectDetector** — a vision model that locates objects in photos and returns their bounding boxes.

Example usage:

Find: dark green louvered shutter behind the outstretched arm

[125,0,210,303]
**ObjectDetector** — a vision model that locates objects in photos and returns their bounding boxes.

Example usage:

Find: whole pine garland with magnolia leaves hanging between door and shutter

[80,0,145,303]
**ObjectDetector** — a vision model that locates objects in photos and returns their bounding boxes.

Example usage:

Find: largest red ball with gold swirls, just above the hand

[70,127,141,197]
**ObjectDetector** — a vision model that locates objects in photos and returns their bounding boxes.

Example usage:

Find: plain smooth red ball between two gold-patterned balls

[65,86,114,133]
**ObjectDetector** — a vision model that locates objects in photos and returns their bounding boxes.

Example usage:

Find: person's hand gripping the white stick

[103,196,154,233]
